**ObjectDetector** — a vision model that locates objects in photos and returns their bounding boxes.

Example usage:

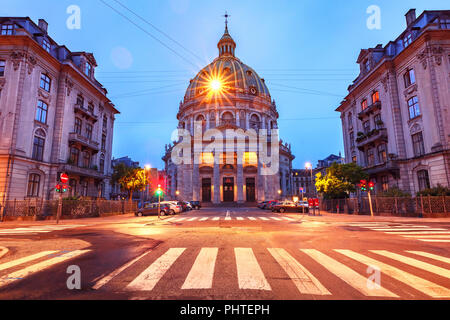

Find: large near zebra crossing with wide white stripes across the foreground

[93,247,450,298]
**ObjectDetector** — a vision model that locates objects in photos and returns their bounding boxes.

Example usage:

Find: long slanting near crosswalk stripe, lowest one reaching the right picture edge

[335,249,450,298]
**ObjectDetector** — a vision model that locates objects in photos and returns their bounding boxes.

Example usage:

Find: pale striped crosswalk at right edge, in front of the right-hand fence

[345,222,450,243]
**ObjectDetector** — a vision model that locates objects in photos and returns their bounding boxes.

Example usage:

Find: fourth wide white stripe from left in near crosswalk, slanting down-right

[267,248,331,295]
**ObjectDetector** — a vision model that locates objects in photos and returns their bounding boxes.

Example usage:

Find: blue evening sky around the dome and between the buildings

[0,0,449,168]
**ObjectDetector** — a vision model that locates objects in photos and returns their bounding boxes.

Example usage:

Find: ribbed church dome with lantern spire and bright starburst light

[184,26,271,102]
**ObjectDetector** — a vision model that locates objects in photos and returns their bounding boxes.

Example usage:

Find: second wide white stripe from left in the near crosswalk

[181,248,219,289]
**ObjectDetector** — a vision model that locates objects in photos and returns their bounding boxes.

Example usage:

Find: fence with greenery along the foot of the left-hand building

[0,199,137,220]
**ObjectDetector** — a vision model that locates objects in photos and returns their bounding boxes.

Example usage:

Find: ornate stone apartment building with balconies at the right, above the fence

[336,9,450,194]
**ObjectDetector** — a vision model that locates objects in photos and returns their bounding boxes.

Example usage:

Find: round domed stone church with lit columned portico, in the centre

[163,23,294,204]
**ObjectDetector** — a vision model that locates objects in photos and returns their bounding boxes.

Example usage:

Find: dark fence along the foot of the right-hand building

[321,196,450,217]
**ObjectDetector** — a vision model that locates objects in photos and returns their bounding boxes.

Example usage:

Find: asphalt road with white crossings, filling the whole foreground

[0,208,450,300]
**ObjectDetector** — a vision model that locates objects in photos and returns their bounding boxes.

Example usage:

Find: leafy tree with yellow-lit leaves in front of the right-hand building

[316,163,368,199]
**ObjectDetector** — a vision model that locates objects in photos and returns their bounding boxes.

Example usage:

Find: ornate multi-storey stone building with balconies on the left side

[0,17,119,201]
